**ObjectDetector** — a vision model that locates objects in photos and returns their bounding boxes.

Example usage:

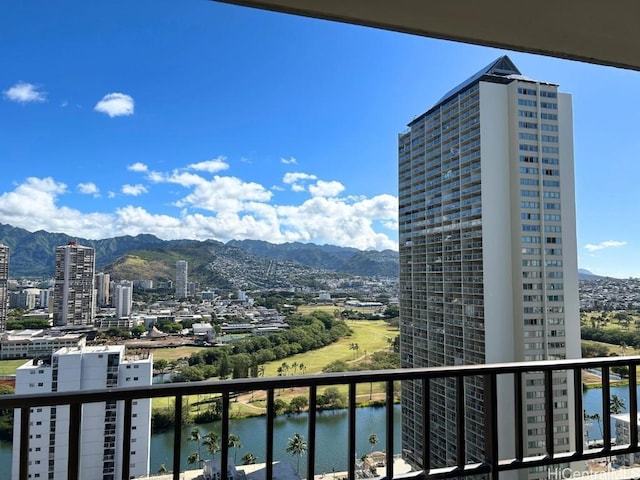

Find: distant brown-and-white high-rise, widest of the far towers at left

[53,242,96,326]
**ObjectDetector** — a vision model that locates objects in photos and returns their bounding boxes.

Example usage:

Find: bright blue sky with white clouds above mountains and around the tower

[0,0,640,277]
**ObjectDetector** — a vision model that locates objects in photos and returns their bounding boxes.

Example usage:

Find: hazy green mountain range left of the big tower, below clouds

[0,224,398,288]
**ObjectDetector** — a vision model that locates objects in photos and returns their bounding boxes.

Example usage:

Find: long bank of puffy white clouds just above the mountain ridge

[0,175,398,250]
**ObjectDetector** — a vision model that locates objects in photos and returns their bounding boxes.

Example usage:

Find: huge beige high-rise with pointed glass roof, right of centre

[398,56,580,478]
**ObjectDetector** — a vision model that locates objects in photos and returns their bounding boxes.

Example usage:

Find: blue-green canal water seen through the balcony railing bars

[0,386,640,479]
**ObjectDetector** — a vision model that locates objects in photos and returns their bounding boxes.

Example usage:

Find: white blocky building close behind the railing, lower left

[12,345,153,480]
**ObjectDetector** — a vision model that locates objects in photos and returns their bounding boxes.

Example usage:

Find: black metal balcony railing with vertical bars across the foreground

[0,356,640,480]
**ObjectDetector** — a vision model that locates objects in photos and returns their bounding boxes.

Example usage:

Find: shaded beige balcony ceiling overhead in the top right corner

[218,0,640,70]
